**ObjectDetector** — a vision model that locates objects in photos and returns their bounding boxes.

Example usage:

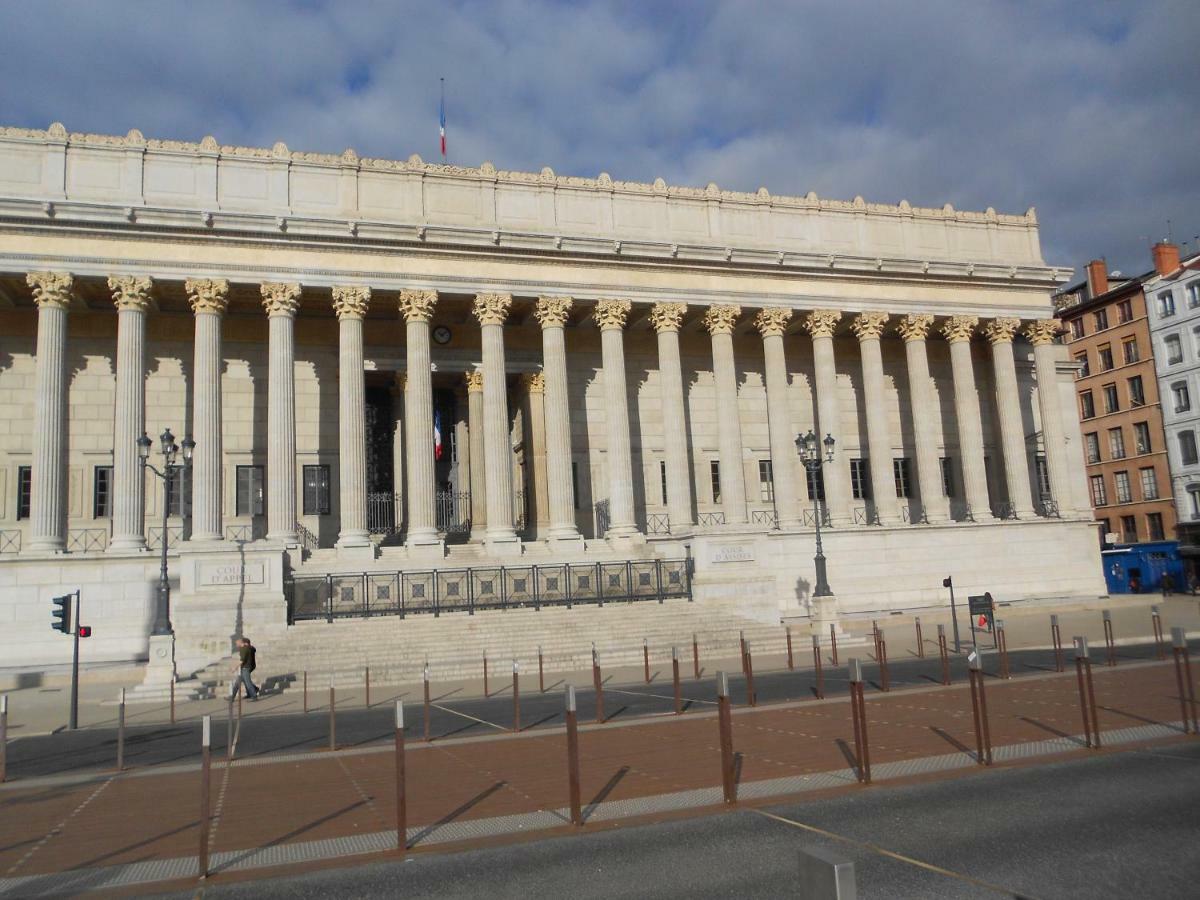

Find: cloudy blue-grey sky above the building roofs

[0,0,1200,274]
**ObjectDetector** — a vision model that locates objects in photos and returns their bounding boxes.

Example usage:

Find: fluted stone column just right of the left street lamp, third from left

[184,278,229,544]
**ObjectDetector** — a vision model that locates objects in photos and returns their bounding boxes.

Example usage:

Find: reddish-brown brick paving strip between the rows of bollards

[0,662,1180,892]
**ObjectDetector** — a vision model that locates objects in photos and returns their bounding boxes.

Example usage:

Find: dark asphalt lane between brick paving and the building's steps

[8,643,1180,780]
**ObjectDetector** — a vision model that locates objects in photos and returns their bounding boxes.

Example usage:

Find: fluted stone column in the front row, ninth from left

[595,300,637,538]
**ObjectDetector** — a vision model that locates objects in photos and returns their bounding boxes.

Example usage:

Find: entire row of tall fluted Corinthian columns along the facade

[16,272,1070,552]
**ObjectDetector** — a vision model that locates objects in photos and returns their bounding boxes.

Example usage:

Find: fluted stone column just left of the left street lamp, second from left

[108,275,152,551]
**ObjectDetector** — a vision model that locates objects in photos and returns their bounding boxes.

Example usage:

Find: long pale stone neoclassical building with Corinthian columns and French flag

[0,124,1104,670]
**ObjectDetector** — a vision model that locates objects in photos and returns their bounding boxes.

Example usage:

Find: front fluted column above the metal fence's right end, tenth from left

[650,304,696,534]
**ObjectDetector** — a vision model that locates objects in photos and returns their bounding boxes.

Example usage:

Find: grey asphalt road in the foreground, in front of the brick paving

[166,740,1200,900]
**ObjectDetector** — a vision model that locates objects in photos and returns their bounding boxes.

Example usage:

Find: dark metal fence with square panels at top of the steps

[284,559,691,623]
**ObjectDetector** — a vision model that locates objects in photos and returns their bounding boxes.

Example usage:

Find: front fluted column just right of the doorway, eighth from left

[534,296,580,541]
